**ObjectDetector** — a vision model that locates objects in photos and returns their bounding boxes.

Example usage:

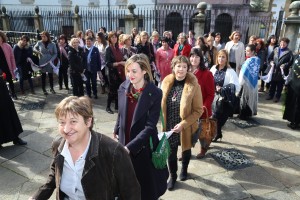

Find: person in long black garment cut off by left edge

[0,69,27,149]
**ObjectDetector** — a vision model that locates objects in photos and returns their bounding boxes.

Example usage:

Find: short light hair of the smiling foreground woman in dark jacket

[54,96,94,131]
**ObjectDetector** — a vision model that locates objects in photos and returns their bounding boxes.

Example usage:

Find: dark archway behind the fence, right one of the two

[215,13,232,43]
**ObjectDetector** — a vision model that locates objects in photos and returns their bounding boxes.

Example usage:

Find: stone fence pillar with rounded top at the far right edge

[283,1,300,51]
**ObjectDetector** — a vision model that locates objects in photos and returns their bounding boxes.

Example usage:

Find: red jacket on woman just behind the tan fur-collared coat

[194,69,215,119]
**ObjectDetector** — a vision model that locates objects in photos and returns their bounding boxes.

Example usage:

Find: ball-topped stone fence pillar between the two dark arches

[193,2,207,37]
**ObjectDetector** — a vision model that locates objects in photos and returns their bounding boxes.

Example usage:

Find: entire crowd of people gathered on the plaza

[0,27,300,200]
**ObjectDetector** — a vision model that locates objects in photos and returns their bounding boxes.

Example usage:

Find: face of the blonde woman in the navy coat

[126,62,146,89]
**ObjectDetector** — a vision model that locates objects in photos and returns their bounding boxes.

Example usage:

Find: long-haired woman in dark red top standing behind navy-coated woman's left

[105,31,125,114]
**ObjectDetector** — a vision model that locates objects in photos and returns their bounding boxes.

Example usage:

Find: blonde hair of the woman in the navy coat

[125,53,153,82]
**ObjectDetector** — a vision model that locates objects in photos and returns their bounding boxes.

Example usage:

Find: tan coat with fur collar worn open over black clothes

[161,72,203,151]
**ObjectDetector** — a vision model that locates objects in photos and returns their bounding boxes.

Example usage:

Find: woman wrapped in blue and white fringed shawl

[239,44,261,120]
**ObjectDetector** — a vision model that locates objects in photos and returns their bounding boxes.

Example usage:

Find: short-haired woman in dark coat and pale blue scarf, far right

[266,38,293,103]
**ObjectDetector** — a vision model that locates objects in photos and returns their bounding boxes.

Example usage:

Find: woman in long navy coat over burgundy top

[114,54,168,200]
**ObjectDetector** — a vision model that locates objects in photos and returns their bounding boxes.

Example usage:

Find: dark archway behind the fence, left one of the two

[165,12,183,39]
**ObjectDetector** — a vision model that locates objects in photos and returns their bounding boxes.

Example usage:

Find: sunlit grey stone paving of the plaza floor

[0,87,300,200]
